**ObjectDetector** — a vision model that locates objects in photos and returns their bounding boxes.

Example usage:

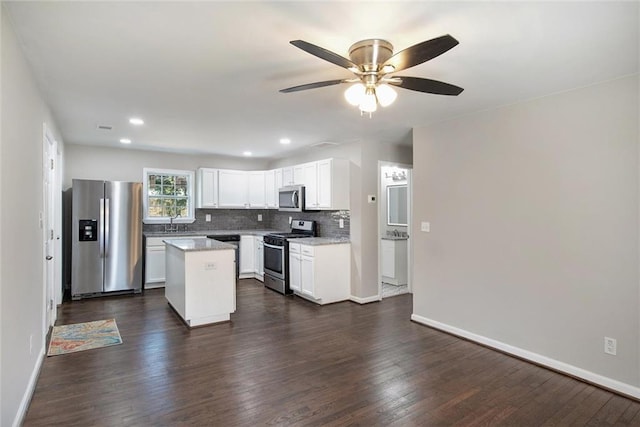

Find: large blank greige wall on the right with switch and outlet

[412,75,640,397]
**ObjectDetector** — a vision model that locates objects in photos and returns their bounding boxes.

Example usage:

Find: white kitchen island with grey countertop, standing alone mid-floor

[164,238,236,327]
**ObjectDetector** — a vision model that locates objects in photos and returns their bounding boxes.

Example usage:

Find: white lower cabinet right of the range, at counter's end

[289,243,351,304]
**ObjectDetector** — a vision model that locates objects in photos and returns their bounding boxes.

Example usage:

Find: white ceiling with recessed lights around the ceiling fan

[3,1,639,158]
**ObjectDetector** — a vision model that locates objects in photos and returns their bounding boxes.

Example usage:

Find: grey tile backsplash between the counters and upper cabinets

[143,209,350,237]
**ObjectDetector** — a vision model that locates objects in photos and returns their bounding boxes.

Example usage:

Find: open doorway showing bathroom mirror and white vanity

[378,161,413,299]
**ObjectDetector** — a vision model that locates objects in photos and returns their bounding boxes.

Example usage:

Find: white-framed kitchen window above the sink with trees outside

[143,168,195,224]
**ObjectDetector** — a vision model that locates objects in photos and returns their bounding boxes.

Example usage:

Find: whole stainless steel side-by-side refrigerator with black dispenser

[71,179,142,299]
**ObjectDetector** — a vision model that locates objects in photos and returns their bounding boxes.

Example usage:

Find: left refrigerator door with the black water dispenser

[71,179,104,296]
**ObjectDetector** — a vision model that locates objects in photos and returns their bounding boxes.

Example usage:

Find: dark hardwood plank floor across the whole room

[24,280,640,426]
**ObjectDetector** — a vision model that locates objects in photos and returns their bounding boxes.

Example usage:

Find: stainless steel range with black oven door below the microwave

[264,219,316,295]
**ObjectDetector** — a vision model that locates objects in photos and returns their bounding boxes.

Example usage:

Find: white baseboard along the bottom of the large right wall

[411,314,640,399]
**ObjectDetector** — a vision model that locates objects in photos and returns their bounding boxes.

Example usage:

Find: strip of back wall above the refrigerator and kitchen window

[63,144,267,189]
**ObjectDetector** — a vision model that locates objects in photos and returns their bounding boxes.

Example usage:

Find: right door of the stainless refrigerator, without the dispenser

[104,181,142,292]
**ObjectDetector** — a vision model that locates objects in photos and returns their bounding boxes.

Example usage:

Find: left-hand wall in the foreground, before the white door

[0,6,61,426]
